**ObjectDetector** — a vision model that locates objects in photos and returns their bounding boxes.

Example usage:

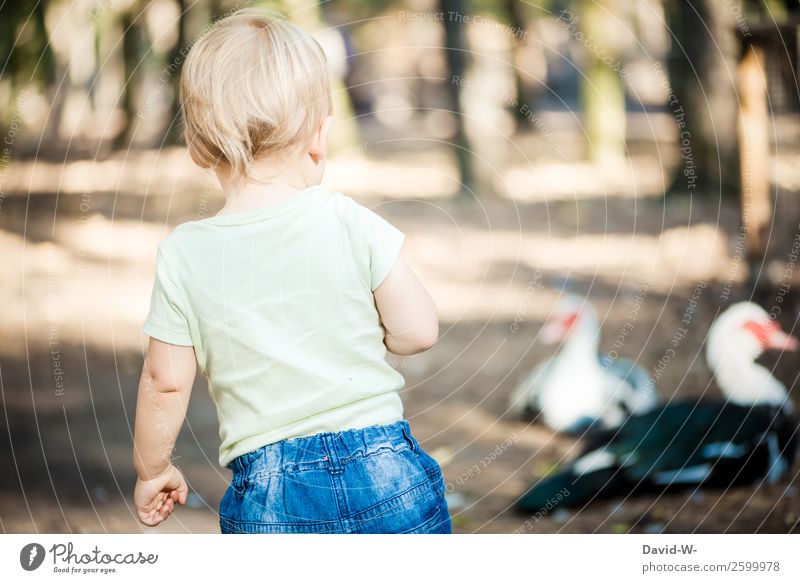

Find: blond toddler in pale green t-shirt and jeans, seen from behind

[134,9,451,533]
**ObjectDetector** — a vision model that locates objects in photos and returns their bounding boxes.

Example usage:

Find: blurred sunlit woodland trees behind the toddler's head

[0,0,798,210]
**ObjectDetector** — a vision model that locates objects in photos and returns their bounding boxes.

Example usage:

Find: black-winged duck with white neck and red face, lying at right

[517,302,798,513]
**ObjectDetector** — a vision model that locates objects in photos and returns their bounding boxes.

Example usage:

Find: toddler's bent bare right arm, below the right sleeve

[374,257,439,355]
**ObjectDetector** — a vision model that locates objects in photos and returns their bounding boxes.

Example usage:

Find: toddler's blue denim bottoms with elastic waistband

[219,420,452,534]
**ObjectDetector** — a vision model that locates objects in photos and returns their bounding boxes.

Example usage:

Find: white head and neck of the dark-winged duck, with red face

[706,302,800,404]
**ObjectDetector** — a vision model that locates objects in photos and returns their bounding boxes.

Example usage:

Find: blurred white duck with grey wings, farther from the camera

[509,295,658,432]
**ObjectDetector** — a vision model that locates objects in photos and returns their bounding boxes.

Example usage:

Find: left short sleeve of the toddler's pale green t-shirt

[142,248,193,346]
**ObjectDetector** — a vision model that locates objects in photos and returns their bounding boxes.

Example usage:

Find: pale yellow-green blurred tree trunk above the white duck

[580,0,626,164]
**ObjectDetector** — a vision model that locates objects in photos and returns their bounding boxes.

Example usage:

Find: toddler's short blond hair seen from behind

[180,8,332,177]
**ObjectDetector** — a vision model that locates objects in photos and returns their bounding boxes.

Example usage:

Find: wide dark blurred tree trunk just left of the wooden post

[666,0,740,196]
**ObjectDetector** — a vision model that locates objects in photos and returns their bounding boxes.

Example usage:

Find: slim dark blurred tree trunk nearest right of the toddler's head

[439,0,475,196]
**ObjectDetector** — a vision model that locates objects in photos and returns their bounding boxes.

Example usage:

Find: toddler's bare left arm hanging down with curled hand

[133,338,197,526]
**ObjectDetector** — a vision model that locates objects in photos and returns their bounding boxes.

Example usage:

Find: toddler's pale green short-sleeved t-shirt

[142,187,404,466]
